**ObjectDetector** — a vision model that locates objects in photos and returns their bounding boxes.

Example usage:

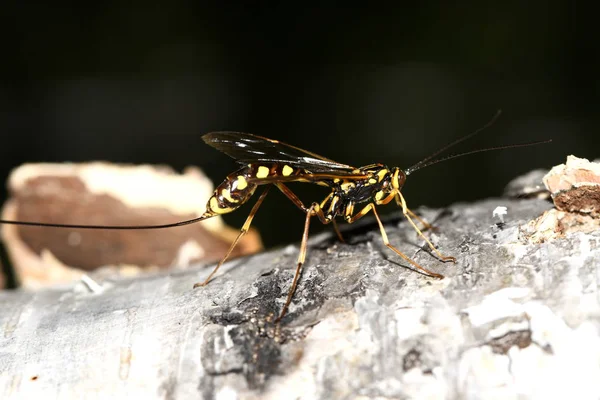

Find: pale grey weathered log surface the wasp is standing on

[0,191,600,399]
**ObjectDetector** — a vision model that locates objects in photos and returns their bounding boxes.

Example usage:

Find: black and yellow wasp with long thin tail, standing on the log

[0,111,550,322]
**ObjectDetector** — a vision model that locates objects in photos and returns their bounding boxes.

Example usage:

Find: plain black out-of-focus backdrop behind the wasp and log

[0,1,600,245]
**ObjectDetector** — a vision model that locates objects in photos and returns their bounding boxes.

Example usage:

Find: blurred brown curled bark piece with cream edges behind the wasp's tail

[2,162,262,287]
